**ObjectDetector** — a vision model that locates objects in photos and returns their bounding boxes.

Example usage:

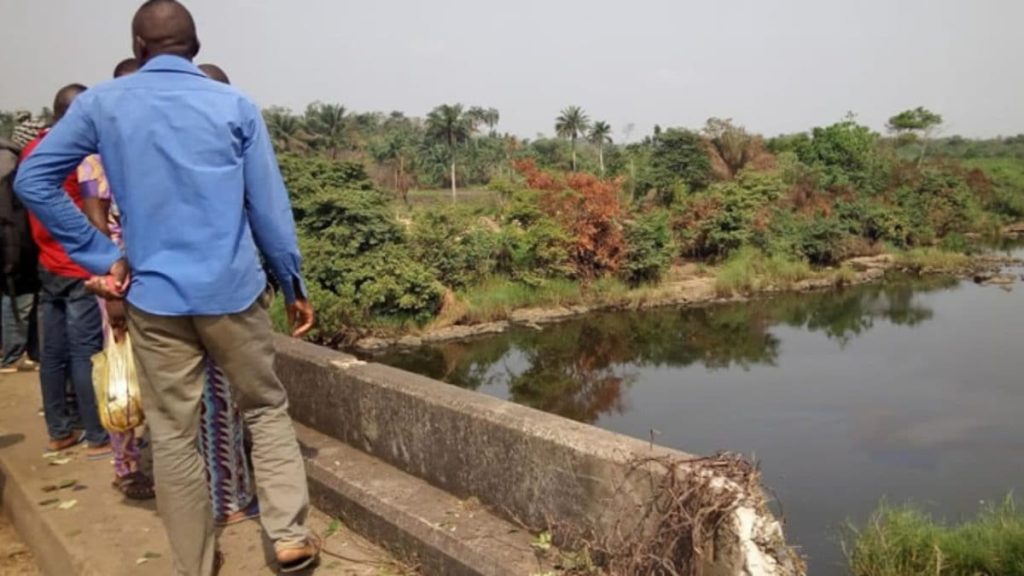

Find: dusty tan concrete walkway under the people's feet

[0,374,402,576]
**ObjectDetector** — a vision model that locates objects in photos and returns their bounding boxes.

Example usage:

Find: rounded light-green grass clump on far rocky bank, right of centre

[715,247,814,296]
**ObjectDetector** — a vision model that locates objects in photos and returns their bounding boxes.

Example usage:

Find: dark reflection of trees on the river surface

[382,278,956,422]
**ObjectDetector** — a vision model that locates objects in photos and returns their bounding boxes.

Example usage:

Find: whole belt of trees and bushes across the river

[6,102,1024,344]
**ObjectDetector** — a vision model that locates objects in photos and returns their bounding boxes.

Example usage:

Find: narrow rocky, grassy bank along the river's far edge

[352,249,1015,354]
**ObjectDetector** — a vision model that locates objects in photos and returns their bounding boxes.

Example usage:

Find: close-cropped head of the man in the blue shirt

[131,0,200,66]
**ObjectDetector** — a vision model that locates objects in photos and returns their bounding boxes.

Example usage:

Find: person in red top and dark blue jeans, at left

[22,84,110,458]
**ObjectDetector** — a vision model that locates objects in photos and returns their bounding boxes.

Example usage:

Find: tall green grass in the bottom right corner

[846,497,1024,576]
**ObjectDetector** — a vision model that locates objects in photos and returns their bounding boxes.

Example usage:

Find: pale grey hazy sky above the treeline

[0,0,1024,140]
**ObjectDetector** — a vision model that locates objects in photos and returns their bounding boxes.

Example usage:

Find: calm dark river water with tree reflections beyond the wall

[378,260,1024,575]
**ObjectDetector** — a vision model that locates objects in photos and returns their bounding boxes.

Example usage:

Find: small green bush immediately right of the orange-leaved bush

[620,210,674,286]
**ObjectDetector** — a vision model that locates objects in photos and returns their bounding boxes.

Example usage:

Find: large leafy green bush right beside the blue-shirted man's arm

[282,159,444,336]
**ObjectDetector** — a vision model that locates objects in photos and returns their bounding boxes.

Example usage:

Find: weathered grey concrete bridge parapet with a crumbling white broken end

[276,337,792,574]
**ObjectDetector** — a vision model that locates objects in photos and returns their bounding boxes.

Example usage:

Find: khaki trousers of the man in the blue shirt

[128,297,309,576]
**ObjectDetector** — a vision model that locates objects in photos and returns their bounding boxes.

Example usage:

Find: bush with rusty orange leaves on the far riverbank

[516,160,626,280]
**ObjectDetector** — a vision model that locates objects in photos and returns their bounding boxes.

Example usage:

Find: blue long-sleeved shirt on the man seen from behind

[14,55,305,316]
